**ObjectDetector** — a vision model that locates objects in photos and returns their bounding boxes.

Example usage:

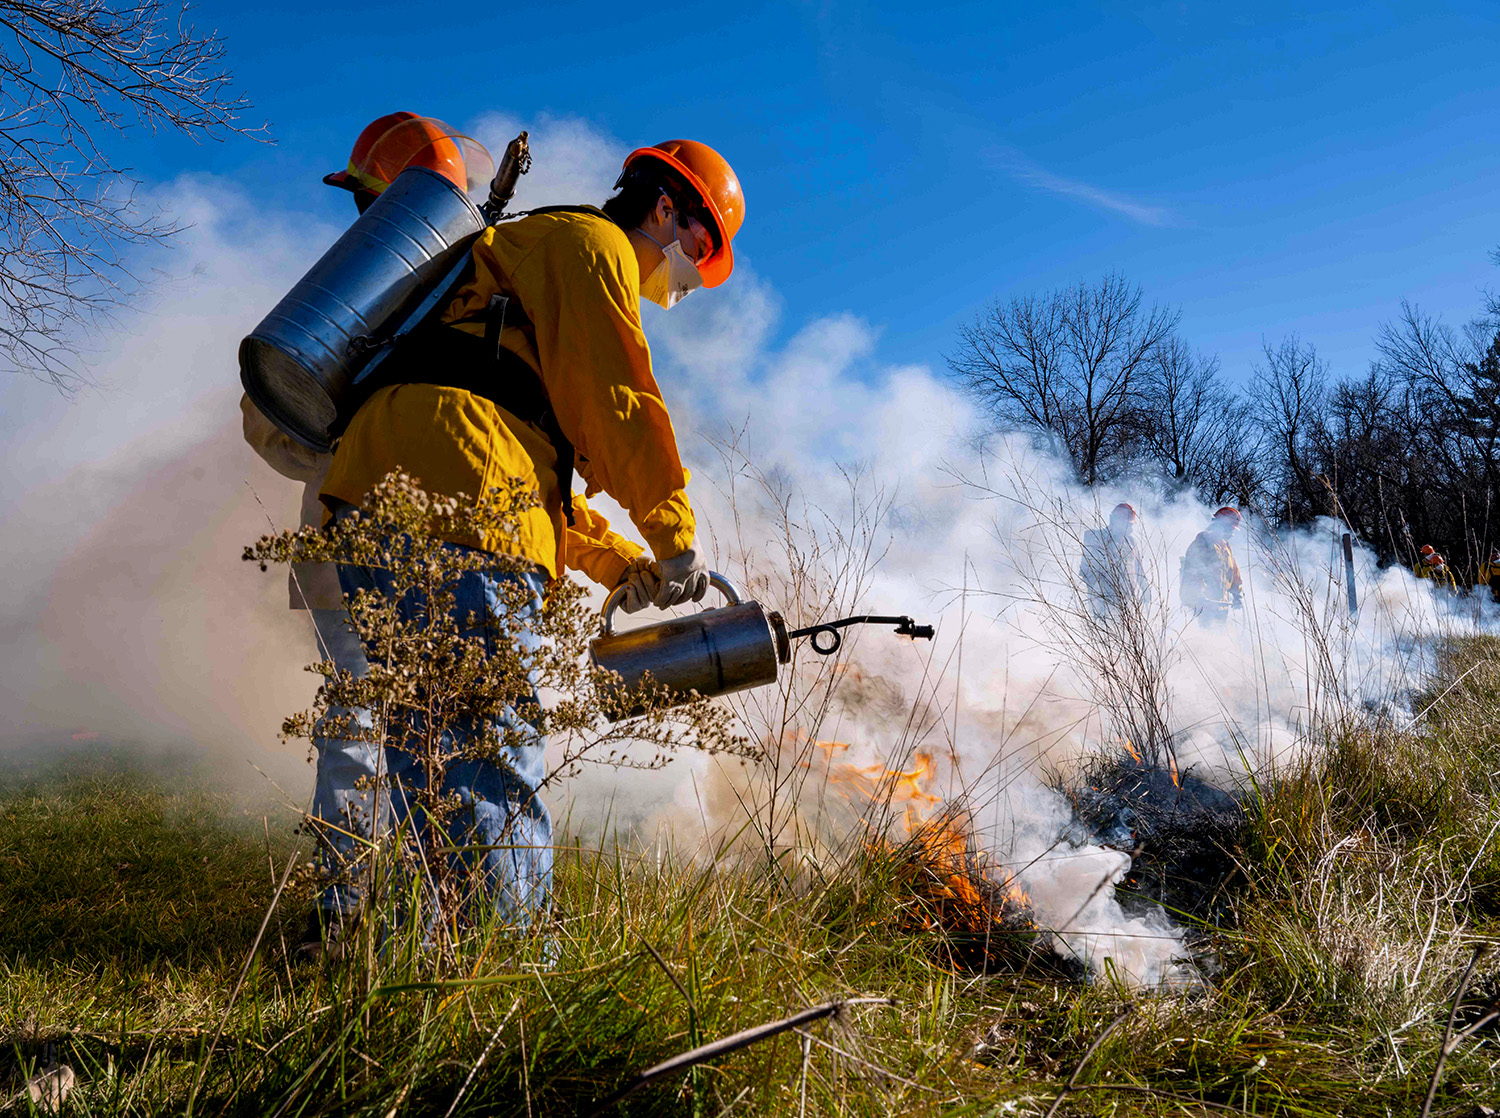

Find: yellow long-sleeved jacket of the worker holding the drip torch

[321,210,696,587]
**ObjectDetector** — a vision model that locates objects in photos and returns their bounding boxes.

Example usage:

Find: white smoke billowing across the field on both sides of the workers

[0,117,1460,984]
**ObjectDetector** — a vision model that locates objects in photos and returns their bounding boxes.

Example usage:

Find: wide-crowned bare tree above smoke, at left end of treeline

[948,275,1179,485]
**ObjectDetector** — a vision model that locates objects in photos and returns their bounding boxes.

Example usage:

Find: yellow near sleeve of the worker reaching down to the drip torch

[510,227,696,560]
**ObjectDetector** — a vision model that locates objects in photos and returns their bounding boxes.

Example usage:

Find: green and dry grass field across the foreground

[0,641,1500,1118]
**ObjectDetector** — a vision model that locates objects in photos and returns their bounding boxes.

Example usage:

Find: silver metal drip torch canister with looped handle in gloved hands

[588,572,792,722]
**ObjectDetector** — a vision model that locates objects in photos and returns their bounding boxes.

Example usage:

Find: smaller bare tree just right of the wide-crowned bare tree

[1137,335,1259,504]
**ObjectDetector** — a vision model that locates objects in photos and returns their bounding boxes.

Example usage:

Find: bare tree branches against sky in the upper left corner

[0,0,259,390]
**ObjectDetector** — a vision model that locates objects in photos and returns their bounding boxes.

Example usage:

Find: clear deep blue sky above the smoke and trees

[128,0,1500,387]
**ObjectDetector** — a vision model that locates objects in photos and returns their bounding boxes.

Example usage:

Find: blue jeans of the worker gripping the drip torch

[339,543,552,924]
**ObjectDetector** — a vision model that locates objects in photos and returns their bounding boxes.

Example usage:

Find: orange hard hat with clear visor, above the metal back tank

[323,113,495,194]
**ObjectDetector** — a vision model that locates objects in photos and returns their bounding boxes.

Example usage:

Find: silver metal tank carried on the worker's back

[240,167,485,450]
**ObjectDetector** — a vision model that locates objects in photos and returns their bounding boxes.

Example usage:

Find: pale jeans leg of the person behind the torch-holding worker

[311,609,386,915]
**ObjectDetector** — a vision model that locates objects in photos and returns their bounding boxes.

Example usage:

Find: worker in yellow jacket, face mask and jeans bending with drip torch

[321,140,744,923]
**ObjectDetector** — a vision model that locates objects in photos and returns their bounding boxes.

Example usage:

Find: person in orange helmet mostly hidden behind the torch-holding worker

[240,113,495,954]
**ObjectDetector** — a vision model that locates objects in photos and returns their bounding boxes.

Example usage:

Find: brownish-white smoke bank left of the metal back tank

[0,177,338,800]
